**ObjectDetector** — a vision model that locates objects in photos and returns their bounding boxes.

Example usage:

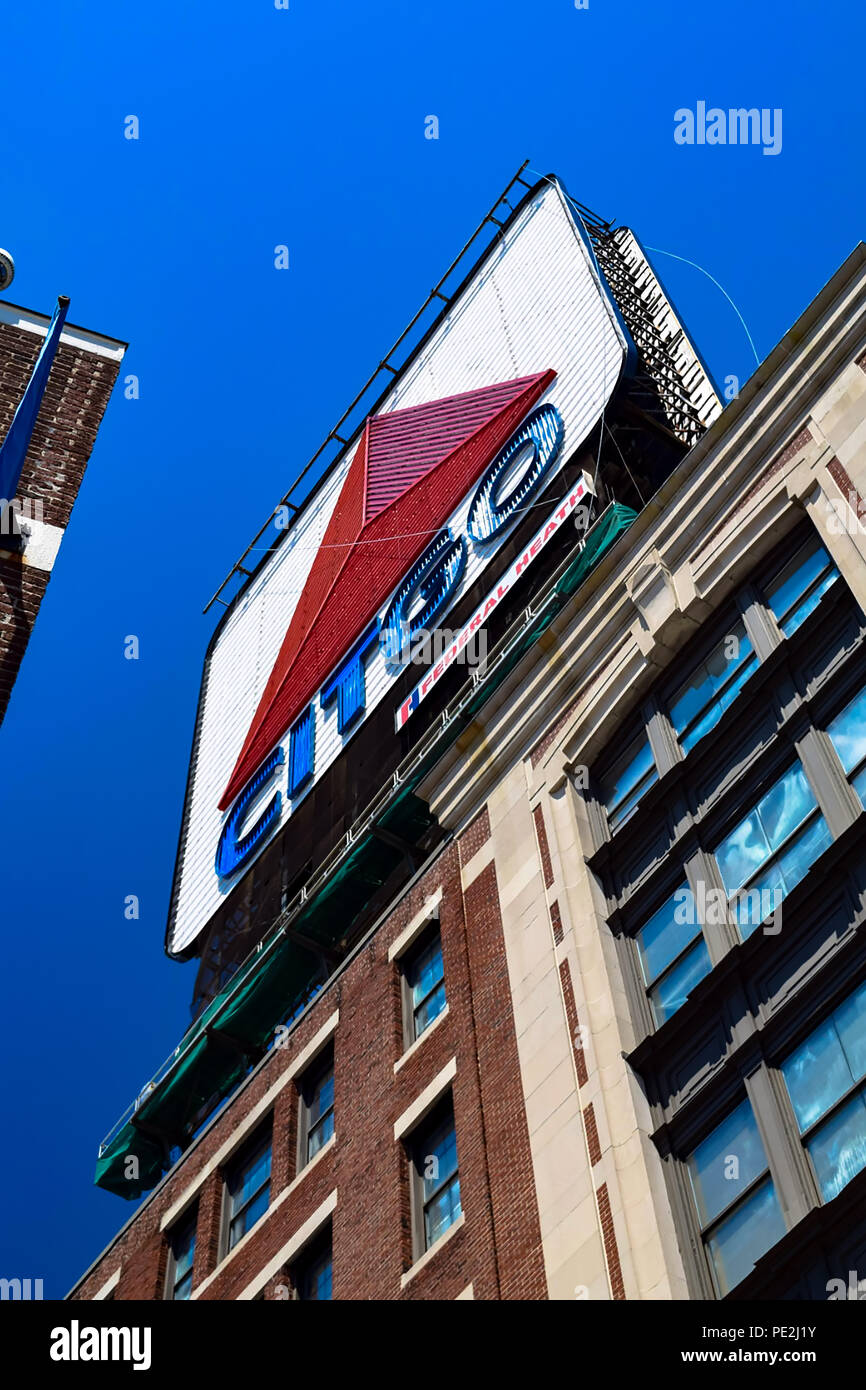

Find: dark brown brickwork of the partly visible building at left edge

[0,322,120,720]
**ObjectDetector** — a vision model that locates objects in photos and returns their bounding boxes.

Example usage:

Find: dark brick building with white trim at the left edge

[0,294,126,719]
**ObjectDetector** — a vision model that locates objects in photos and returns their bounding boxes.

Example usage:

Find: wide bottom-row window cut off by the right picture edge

[781,984,866,1202]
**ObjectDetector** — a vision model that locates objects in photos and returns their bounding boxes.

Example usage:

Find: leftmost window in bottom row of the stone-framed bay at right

[687,1099,785,1297]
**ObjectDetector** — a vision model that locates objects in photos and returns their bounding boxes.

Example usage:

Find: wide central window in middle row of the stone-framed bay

[716,762,831,938]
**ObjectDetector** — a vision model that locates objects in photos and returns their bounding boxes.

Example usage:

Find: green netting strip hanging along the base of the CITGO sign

[95,517,637,1198]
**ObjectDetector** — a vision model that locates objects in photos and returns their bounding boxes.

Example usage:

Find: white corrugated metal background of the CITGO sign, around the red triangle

[171,185,624,952]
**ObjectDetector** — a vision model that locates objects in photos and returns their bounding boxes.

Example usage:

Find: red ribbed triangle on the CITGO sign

[220,371,556,810]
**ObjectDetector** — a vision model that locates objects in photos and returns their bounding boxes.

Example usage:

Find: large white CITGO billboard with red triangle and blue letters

[167,181,632,955]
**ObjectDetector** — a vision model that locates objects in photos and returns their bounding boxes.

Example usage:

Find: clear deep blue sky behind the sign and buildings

[0,0,866,1297]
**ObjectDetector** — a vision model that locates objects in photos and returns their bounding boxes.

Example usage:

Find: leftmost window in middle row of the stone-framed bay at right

[635,884,713,1024]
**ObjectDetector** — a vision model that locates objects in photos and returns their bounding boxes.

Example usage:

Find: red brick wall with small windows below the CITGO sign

[75,842,546,1300]
